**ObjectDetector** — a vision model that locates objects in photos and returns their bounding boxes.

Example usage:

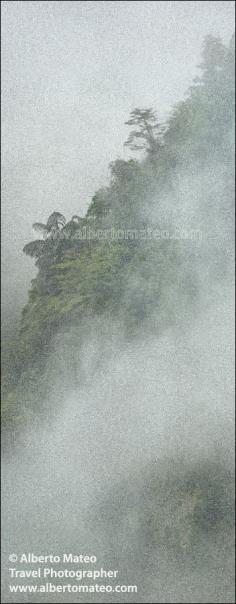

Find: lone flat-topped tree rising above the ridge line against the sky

[125,109,163,155]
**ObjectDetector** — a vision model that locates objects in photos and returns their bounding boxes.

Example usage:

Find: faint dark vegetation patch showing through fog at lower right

[99,458,234,569]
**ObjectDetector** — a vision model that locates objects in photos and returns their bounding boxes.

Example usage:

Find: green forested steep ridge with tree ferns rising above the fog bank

[2,36,234,429]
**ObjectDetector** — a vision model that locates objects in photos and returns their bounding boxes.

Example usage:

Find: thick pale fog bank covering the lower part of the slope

[3,289,234,602]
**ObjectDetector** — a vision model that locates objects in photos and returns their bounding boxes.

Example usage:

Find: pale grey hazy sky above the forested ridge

[2,1,234,324]
